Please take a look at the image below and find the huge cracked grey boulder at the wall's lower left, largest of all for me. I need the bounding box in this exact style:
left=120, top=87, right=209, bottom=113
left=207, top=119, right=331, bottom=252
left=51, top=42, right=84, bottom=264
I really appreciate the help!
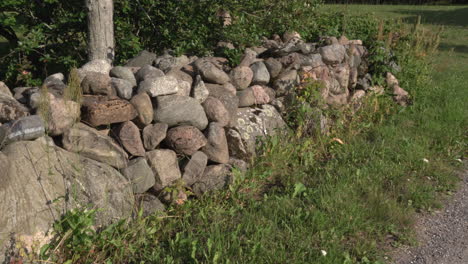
left=0, top=138, right=134, bottom=262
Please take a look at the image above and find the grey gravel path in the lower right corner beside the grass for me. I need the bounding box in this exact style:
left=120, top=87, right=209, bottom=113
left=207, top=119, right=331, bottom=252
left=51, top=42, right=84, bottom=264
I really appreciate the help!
left=392, top=166, right=468, bottom=264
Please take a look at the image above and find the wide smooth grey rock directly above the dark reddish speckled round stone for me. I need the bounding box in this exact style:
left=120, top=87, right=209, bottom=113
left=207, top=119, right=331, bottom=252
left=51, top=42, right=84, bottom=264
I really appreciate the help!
left=154, top=95, right=208, bottom=130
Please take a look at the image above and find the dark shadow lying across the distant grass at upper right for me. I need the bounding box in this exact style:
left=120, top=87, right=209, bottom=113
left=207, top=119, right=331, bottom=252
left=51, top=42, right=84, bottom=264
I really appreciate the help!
left=394, top=7, right=468, bottom=27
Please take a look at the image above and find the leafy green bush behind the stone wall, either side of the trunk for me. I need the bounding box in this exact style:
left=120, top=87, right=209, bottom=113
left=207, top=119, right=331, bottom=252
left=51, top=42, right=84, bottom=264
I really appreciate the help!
left=0, top=0, right=321, bottom=85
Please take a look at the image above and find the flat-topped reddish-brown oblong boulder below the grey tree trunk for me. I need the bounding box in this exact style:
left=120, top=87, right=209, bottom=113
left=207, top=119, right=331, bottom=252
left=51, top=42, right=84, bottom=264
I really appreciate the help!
left=82, top=96, right=138, bottom=127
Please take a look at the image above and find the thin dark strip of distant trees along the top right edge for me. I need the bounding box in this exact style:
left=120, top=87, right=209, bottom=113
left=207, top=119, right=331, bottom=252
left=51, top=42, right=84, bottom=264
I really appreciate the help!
left=325, top=0, right=468, bottom=5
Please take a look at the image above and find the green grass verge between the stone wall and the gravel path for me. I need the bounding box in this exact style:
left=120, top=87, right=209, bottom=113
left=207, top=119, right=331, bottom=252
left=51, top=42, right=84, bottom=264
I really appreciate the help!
left=35, top=6, right=468, bottom=264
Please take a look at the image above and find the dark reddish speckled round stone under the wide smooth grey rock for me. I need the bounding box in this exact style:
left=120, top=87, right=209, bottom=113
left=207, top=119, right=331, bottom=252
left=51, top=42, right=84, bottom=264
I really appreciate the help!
left=165, top=126, right=207, bottom=155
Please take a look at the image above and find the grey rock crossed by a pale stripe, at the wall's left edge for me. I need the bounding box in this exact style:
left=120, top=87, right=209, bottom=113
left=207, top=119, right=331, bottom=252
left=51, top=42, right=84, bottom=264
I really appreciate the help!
left=0, top=115, right=45, bottom=145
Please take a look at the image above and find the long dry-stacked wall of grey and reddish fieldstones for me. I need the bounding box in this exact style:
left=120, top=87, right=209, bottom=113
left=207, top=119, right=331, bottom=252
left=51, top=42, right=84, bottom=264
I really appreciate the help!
left=0, top=33, right=407, bottom=260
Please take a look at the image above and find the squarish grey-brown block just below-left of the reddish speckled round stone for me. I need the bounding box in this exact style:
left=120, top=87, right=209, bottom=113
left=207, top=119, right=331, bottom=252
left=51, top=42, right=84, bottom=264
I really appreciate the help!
left=146, top=149, right=182, bottom=191
